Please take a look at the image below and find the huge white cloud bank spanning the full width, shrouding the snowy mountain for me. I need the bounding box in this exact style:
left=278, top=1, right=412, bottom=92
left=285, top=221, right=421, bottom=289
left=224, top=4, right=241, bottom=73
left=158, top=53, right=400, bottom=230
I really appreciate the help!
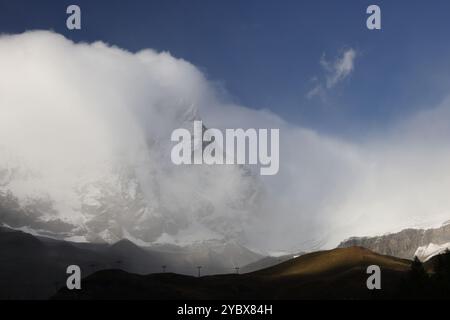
left=0, top=32, right=450, bottom=251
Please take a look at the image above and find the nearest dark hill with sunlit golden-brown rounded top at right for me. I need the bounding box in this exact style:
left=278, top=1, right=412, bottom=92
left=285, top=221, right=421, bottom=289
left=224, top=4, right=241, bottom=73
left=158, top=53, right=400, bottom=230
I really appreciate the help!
left=54, top=247, right=411, bottom=300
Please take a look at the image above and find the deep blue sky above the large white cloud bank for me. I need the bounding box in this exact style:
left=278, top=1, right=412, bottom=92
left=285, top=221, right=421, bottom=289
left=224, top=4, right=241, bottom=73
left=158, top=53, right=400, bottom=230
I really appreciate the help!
left=0, top=0, right=450, bottom=137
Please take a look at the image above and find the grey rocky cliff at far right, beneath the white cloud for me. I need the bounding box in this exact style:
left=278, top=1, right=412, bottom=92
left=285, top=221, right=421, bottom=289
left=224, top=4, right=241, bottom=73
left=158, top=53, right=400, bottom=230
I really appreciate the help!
left=338, top=223, right=450, bottom=259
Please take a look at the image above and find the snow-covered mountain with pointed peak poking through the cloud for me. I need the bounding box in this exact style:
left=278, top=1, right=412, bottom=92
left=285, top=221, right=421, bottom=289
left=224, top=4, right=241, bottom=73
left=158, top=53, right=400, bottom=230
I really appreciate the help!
left=0, top=106, right=263, bottom=245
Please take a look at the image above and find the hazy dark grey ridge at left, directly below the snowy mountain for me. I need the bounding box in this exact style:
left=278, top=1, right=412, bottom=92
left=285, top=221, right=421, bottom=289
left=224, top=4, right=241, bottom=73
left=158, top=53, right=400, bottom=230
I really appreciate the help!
left=0, top=227, right=262, bottom=300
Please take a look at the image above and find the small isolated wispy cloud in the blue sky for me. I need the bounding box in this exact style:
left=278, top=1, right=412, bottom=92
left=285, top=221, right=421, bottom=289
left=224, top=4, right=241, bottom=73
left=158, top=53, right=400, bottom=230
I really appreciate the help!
left=306, top=48, right=357, bottom=99
